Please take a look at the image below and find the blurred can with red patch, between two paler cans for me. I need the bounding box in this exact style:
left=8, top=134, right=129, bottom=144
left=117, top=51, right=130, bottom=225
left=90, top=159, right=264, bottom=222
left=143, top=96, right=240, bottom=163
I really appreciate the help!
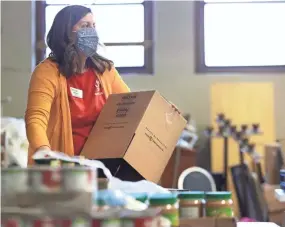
left=29, top=166, right=62, bottom=193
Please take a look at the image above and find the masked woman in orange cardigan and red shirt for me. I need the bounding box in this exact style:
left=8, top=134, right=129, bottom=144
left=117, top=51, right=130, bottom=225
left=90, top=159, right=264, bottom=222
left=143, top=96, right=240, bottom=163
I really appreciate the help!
left=25, top=5, right=130, bottom=165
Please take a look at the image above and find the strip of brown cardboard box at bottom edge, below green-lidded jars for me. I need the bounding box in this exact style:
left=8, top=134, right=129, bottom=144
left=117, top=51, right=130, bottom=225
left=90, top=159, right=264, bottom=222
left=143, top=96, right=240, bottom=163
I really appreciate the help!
left=180, top=218, right=237, bottom=227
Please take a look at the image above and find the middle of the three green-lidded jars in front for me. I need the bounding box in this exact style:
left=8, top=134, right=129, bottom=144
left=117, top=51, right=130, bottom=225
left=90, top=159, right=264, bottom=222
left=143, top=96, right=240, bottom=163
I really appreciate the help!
left=178, top=191, right=205, bottom=218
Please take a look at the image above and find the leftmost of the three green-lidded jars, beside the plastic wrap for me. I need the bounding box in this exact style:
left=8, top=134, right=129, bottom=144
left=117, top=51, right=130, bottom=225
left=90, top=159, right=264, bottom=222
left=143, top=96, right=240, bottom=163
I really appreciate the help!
left=149, top=193, right=179, bottom=226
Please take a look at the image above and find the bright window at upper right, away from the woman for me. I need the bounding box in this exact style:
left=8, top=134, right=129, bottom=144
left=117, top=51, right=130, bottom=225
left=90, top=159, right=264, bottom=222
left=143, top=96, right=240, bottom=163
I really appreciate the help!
left=195, top=0, right=285, bottom=72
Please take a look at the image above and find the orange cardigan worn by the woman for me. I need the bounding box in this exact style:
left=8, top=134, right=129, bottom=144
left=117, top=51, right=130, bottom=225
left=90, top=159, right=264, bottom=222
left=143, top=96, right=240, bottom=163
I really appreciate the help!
left=25, top=59, right=130, bottom=165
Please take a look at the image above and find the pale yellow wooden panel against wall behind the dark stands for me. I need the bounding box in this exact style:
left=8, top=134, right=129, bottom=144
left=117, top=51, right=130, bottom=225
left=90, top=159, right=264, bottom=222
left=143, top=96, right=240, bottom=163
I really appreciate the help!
left=211, top=83, right=276, bottom=215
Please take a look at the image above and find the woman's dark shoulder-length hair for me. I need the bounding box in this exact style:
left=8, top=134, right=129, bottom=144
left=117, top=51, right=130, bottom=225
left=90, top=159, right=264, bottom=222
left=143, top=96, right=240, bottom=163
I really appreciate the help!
left=47, top=5, right=113, bottom=78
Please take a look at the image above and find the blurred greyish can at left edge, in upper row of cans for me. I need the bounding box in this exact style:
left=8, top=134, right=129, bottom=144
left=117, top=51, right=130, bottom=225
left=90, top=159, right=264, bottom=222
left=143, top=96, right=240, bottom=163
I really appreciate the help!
left=1, top=167, right=29, bottom=195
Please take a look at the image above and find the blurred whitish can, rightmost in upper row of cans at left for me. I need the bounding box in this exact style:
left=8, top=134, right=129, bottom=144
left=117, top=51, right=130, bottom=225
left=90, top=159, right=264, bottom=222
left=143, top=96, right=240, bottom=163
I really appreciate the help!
left=62, top=166, right=97, bottom=192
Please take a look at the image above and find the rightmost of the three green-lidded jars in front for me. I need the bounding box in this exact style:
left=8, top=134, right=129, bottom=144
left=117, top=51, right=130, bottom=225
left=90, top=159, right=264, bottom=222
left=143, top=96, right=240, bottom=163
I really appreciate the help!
left=205, top=191, right=234, bottom=217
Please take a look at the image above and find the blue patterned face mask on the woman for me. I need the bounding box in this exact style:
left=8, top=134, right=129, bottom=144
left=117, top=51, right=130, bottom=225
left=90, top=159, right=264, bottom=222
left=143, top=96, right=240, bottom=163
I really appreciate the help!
left=76, top=28, right=99, bottom=57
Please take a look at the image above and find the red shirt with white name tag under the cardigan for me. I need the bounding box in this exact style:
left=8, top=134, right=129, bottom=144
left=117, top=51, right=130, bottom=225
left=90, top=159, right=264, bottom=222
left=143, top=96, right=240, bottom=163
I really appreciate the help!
left=67, top=69, right=106, bottom=155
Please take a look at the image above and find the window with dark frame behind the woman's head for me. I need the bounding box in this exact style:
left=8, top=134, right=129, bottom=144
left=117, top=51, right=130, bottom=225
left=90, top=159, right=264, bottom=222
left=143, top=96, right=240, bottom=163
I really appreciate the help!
left=37, top=0, right=153, bottom=74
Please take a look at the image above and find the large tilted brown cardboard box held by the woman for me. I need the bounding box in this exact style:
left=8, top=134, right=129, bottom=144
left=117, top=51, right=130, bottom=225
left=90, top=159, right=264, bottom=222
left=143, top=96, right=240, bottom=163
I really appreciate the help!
left=81, top=91, right=186, bottom=183
